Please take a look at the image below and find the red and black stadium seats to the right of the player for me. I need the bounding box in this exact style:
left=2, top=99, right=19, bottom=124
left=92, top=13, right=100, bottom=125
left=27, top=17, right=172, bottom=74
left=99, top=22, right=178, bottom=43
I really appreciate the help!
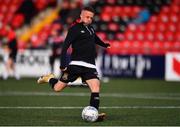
left=92, top=0, right=180, bottom=55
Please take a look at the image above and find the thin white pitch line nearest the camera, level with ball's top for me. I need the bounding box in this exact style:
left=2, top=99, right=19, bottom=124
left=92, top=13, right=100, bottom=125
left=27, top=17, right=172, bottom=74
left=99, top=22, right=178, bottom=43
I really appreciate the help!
left=0, top=106, right=180, bottom=110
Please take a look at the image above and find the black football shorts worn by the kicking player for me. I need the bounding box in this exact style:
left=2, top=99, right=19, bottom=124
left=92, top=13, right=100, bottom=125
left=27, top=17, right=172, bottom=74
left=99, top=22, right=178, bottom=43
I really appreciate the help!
left=60, top=65, right=99, bottom=83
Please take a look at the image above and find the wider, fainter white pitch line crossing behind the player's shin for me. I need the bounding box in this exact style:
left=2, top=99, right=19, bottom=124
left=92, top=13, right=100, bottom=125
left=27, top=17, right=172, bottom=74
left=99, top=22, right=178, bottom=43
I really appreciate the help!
left=0, top=91, right=180, bottom=100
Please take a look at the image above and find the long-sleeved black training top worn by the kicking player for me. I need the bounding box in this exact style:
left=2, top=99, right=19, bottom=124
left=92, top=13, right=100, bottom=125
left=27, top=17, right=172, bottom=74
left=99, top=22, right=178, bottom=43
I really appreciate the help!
left=60, top=23, right=109, bottom=68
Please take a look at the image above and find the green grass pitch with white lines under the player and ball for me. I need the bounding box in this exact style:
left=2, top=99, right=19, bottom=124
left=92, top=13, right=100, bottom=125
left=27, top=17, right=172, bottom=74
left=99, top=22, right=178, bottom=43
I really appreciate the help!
left=0, top=78, right=180, bottom=126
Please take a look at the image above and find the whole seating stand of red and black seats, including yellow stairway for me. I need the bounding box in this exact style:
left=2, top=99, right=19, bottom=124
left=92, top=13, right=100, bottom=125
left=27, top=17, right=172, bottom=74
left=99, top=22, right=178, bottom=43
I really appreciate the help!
left=0, top=0, right=180, bottom=55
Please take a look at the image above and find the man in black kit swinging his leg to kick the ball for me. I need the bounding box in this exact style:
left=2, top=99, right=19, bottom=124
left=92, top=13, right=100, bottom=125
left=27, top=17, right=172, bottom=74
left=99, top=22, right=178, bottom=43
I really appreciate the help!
left=37, top=7, right=110, bottom=121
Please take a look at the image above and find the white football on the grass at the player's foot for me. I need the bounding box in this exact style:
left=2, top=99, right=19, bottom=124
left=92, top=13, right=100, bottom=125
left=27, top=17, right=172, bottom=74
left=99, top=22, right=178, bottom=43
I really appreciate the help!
left=81, top=106, right=98, bottom=122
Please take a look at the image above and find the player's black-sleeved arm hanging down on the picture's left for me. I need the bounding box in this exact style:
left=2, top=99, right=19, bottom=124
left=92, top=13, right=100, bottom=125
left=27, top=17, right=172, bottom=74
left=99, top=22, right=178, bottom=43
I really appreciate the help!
left=60, top=27, right=77, bottom=71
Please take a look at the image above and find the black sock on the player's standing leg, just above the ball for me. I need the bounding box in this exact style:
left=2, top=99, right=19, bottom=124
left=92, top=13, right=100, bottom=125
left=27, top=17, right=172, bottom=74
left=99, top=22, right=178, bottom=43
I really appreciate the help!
left=90, top=93, right=100, bottom=110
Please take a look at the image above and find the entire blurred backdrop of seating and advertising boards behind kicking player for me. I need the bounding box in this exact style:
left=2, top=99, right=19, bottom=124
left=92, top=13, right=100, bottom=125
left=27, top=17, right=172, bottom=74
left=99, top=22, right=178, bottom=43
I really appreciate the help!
left=0, top=0, right=180, bottom=81
